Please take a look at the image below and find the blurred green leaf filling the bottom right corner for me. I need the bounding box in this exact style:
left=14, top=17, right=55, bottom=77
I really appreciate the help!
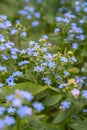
left=71, top=121, right=87, bottom=130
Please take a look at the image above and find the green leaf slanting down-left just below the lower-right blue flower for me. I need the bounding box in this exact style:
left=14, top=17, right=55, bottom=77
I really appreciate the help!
left=53, top=110, right=70, bottom=124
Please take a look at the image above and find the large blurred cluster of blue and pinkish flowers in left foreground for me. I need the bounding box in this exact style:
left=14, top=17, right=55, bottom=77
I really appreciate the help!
left=0, top=89, right=44, bottom=130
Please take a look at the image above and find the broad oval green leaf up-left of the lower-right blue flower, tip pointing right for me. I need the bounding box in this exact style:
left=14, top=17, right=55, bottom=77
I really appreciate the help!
left=44, top=94, right=63, bottom=106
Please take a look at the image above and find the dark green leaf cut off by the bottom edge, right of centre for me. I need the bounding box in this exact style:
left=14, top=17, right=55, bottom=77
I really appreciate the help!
left=42, top=122, right=64, bottom=130
